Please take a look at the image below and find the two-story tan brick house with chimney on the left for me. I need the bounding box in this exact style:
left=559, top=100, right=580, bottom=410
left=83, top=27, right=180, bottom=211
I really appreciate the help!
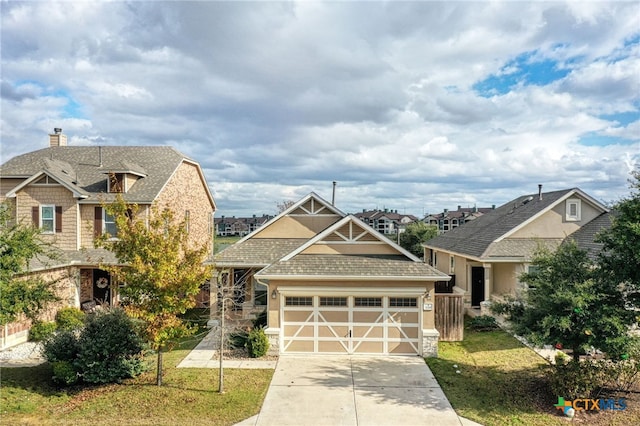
left=0, top=129, right=215, bottom=346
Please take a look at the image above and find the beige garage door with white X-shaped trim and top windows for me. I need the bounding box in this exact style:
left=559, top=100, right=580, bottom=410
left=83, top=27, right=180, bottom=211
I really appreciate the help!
left=282, top=295, right=421, bottom=355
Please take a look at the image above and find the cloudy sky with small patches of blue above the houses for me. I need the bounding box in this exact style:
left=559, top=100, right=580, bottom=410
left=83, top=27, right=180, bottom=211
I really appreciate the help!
left=0, top=0, right=640, bottom=217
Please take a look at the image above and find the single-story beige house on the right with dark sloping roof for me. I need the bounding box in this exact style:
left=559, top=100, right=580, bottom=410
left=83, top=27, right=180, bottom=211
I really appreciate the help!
left=424, top=186, right=608, bottom=308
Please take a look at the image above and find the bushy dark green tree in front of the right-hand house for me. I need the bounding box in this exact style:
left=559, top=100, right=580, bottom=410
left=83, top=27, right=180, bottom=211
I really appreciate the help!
left=492, top=240, right=633, bottom=360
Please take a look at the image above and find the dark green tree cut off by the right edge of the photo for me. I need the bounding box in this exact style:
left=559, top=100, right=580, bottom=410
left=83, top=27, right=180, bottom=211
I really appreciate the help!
left=598, top=170, right=640, bottom=308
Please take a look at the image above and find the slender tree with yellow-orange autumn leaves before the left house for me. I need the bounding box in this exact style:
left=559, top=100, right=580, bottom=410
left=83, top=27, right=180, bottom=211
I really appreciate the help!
left=96, top=197, right=211, bottom=386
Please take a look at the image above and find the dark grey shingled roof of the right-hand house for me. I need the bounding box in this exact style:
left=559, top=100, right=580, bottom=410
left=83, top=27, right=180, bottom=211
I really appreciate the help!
left=424, top=188, right=598, bottom=258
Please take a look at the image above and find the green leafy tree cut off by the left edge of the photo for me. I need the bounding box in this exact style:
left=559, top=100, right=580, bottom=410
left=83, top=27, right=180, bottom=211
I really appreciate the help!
left=0, top=203, right=59, bottom=325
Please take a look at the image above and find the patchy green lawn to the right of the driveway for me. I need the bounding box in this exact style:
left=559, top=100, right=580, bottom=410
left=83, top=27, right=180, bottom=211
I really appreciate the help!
left=427, top=328, right=640, bottom=426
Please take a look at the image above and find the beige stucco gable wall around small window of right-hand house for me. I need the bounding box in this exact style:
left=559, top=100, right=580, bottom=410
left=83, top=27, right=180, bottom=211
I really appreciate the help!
left=509, top=197, right=602, bottom=238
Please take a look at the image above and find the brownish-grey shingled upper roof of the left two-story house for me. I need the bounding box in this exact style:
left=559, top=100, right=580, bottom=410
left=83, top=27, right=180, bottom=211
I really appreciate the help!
left=0, top=146, right=197, bottom=203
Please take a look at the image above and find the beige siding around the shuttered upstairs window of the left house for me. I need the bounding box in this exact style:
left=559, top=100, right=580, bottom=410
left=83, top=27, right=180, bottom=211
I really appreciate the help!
left=16, top=185, right=78, bottom=250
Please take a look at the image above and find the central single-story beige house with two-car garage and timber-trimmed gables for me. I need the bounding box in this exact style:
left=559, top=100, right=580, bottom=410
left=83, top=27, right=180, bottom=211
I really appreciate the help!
left=215, top=193, right=449, bottom=356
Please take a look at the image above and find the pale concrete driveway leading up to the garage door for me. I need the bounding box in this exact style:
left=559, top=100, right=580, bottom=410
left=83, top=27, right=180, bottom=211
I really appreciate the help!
left=249, top=356, right=466, bottom=426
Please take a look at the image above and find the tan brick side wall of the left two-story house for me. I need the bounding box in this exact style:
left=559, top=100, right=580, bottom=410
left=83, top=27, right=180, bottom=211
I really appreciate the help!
left=156, top=162, right=213, bottom=250
